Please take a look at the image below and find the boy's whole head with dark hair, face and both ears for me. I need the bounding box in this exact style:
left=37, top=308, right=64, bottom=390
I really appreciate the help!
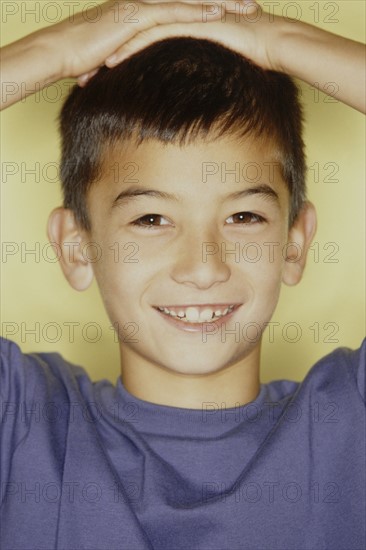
left=49, top=38, right=315, bottom=383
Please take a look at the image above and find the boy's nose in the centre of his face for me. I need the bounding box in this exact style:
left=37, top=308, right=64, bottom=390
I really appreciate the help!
left=171, top=230, right=231, bottom=290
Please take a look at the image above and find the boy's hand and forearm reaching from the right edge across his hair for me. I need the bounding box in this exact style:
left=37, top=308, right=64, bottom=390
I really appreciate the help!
left=101, top=0, right=366, bottom=113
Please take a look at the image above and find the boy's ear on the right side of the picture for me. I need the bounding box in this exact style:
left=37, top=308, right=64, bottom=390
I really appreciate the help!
left=282, top=201, right=316, bottom=286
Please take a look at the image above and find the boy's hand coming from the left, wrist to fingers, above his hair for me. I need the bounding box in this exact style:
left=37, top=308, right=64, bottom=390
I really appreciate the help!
left=40, top=0, right=230, bottom=85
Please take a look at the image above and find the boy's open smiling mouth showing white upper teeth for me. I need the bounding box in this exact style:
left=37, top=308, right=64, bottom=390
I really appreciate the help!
left=154, top=304, right=241, bottom=325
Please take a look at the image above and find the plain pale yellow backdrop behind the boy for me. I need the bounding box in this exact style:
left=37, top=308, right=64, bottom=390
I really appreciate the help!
left=1, top=0, right=365, bottom=382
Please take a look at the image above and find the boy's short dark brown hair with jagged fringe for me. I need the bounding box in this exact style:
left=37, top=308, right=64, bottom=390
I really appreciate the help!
left=60, top=37, right=306, bottom=230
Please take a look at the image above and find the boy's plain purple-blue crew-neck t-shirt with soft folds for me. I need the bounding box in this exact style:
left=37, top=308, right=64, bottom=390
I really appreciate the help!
left=0, top=339, right=366, bottom=550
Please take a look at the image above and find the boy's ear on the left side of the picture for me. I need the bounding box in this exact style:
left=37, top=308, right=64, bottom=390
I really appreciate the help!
left=47, top=207, right=93, bottom=290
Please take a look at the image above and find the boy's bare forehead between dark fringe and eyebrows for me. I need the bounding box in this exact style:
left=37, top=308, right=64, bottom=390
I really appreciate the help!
left=90, top=136, right=288, bottom=206
